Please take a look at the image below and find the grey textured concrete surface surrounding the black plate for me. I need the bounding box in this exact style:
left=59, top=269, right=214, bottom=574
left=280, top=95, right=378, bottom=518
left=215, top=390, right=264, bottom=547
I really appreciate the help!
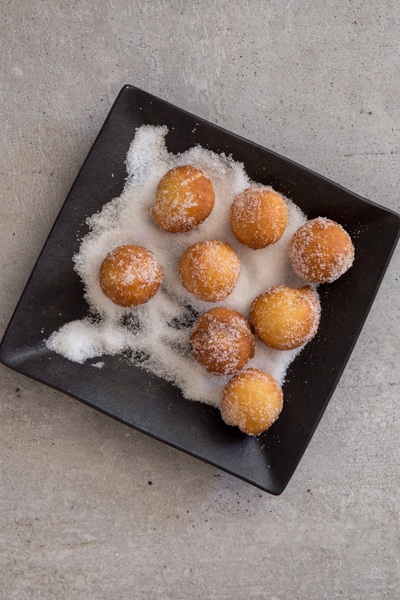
left=0, top=0, right=400, bottom=600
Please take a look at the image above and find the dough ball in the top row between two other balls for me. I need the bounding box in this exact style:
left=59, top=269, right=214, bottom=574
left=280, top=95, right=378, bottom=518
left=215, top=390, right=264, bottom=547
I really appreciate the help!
left=230, top=186, right=289, bottom=250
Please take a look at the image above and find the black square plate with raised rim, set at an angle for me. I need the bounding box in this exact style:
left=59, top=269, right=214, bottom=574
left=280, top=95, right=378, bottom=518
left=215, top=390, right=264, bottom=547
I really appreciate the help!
left=0, top=86, right=400, bottom=494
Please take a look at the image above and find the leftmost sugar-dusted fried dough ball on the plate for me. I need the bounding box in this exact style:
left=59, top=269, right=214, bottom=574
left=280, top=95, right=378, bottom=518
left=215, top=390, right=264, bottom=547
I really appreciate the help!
left=99, top=245, right=164, bottom=307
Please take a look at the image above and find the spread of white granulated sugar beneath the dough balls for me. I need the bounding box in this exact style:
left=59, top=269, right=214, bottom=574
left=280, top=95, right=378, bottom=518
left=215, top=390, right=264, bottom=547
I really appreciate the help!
left=46, top=126, right=306, bottom=406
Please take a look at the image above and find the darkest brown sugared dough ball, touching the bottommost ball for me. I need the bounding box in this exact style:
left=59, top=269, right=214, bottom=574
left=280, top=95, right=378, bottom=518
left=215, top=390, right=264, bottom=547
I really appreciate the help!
left=190, top=306, right=255, bottom=375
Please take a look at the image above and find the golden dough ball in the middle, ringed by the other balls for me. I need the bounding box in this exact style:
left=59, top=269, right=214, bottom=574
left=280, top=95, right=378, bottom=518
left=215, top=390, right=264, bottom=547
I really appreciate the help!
left=179, top=240, right=240, bottom=302
